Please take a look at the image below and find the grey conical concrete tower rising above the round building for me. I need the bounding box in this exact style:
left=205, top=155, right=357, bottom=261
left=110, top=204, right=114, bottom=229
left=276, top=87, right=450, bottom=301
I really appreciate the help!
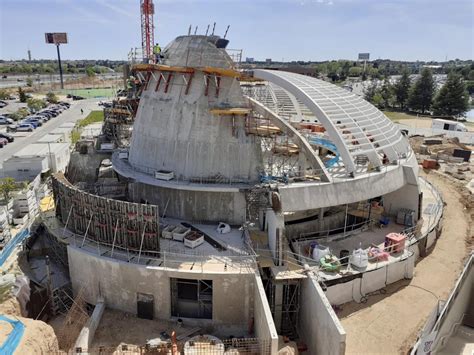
left=129, top=36, right=261, bottom=181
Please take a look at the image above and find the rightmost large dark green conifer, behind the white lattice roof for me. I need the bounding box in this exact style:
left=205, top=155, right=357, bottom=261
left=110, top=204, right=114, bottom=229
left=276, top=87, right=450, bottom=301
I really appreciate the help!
left=433, top=72, right=469, bottom=117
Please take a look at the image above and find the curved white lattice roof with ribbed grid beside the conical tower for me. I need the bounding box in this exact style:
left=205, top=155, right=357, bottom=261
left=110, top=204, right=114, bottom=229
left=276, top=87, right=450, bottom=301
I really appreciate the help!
left=254, top=69, right=410, bottom=172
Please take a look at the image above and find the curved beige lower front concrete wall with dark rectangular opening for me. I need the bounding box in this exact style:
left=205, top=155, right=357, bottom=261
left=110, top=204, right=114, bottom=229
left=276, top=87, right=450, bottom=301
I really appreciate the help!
left=68, top=245, right=255, bottom=336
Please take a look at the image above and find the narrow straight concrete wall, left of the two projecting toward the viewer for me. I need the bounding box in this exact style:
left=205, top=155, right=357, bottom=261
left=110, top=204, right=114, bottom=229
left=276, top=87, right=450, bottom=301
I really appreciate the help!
left=253, top=275, right=278, bottom=354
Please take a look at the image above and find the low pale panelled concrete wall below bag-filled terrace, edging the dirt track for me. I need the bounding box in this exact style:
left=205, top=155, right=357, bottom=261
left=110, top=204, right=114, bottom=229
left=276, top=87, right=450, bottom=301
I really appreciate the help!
left=326, top=254, right=416, bottom=305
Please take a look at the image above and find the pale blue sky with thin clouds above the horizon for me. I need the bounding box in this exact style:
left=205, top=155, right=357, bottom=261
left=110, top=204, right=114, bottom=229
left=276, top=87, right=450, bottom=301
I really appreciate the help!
left=0, top=0, right=474, bottom=61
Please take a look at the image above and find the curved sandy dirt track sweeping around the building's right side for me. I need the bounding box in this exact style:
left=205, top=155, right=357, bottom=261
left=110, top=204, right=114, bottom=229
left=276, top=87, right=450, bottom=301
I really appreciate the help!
left=338, top=174, right=473, bottom=354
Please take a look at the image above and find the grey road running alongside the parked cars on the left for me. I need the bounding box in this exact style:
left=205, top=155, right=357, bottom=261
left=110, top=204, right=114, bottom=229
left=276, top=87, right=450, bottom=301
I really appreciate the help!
left=0, top=99, right=101, bottom=175
